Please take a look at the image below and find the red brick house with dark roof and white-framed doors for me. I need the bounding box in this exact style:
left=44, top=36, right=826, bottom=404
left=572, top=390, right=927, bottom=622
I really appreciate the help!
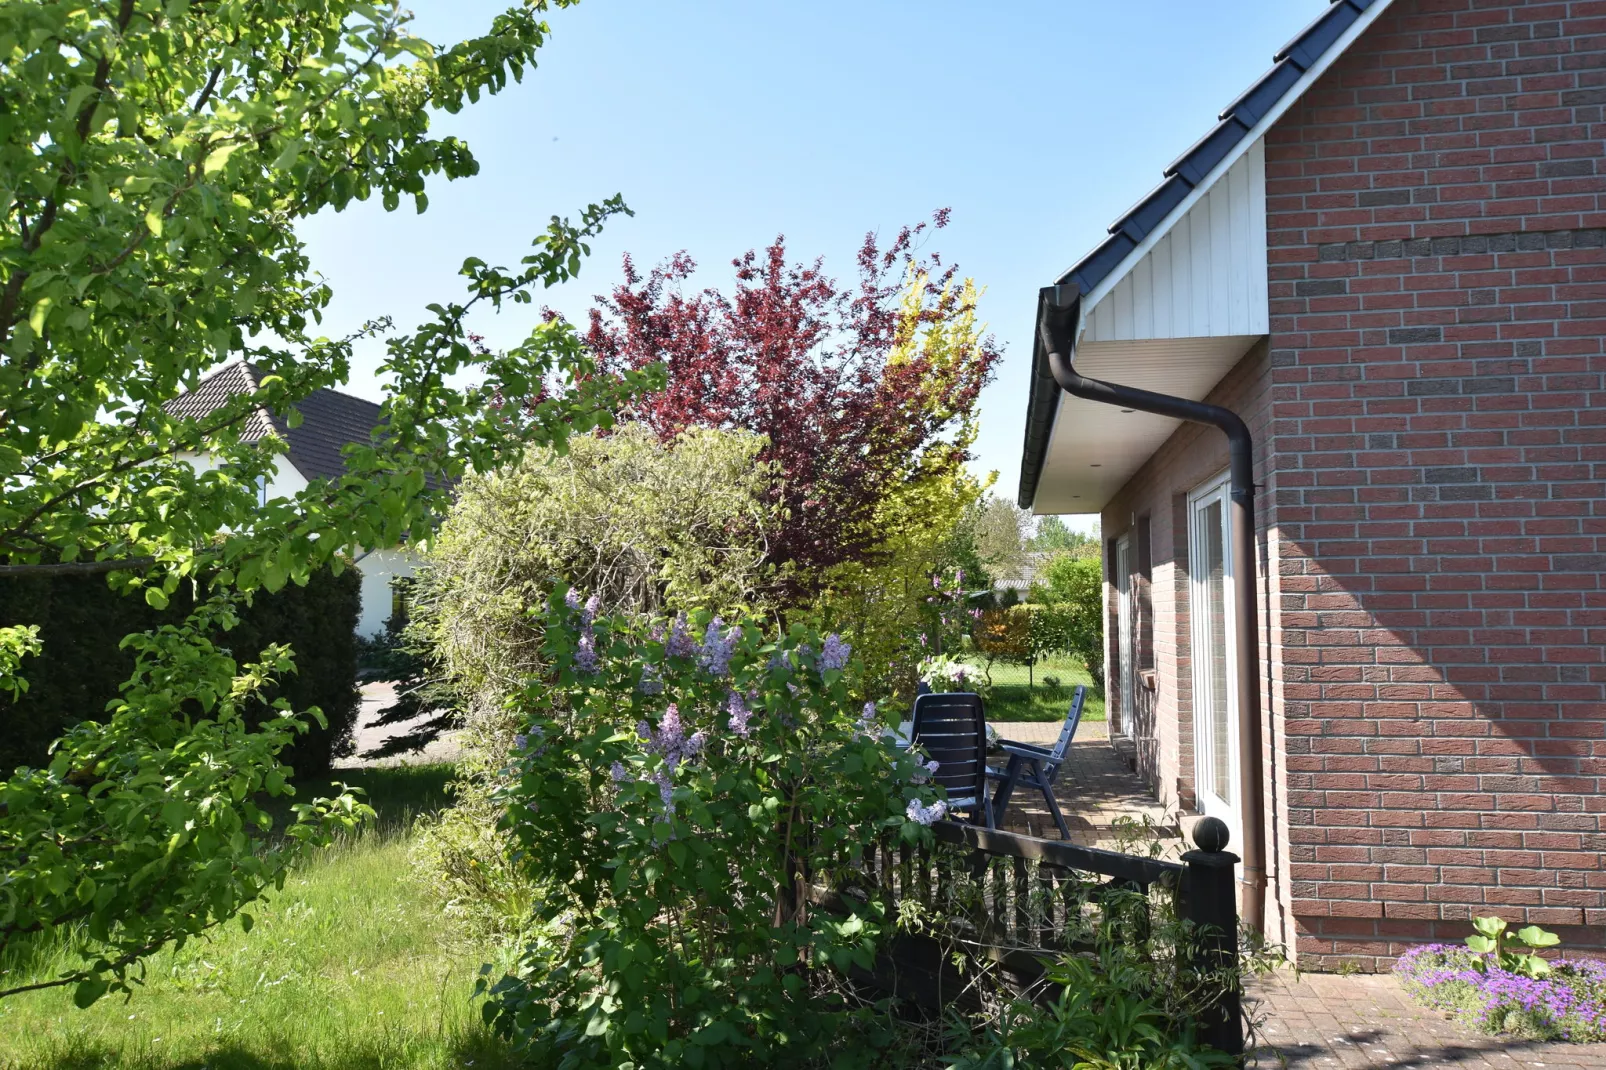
left=1020, top=0, right=1606, bottom=969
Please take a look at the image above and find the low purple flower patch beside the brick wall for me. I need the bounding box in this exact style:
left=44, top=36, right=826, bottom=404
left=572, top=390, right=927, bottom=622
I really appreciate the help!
left=1394, top=943, right=1606, bottom=1041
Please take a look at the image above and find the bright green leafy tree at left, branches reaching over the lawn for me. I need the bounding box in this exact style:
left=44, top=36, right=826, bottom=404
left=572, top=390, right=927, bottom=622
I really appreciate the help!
left=0, top=0, right=655, bottom=1006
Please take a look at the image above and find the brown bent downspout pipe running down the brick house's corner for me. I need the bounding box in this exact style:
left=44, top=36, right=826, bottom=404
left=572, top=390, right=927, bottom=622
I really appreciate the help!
left=1037, top=286, right=1266, bottom=933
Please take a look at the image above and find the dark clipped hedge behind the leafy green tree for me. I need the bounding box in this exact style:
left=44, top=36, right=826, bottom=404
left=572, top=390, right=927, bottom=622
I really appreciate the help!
left=0, top=569, right=361, bottom=776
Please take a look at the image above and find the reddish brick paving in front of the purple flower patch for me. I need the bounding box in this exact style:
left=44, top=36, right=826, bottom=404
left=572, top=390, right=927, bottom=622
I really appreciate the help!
left=1249, top=974, right=1606, bottom=1070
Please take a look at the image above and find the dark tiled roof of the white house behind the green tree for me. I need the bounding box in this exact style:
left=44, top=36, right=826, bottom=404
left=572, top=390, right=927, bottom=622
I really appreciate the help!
left=165, top=360, right=379, bottom=479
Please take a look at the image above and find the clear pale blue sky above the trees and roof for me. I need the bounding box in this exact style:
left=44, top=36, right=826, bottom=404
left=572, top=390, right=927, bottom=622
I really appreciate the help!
left=302, top=0, right=1327, bottom=530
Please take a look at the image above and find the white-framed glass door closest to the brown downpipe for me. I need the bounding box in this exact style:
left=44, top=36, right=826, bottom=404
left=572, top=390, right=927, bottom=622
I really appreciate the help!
left=1188, top=476, right=1238, bottom=839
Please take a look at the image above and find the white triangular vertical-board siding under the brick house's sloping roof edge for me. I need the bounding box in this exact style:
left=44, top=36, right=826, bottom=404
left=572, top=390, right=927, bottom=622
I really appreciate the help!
left=1082, top=140, right=1270, bottom=344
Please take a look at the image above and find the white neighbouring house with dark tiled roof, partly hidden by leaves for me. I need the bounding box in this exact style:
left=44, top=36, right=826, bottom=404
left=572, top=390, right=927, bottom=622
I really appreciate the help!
left=167, top=360, right=414, bottom=635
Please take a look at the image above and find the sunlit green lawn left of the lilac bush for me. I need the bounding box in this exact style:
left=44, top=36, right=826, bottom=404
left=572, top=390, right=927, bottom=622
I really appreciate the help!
left=0, top=766, right=517, bottom=1070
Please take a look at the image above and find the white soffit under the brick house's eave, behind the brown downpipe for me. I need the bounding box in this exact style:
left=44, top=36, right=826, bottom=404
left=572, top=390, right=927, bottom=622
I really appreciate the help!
left=1033, top=333, right=1264, bottom=516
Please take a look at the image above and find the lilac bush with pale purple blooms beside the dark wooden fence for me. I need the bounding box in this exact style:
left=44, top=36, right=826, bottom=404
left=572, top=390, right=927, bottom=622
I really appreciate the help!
left=483, top=588, right=943, bottom=1068
